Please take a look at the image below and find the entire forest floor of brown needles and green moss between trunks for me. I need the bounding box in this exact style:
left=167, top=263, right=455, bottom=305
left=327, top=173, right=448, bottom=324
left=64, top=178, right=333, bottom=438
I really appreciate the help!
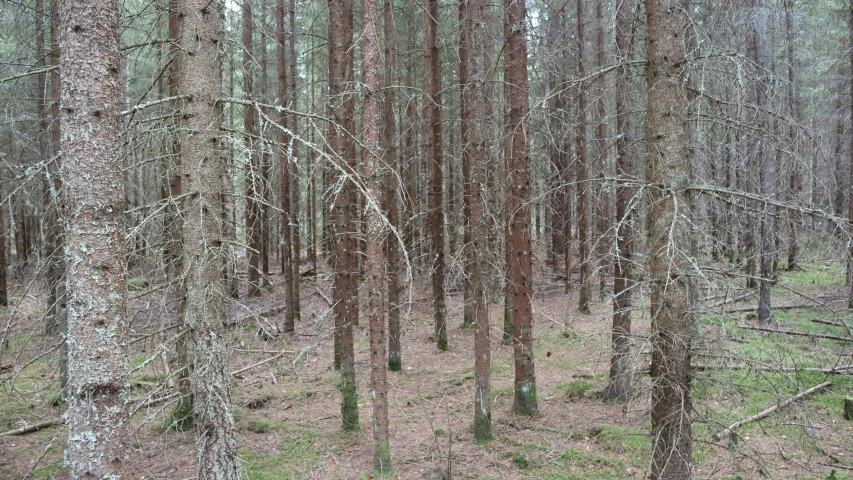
left=0, top=253, right=853, bottom=480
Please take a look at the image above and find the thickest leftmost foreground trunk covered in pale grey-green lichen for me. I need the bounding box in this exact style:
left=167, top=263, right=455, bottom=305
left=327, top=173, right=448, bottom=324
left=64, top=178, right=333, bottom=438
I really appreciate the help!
left=59, top=0, right=130, bottom=478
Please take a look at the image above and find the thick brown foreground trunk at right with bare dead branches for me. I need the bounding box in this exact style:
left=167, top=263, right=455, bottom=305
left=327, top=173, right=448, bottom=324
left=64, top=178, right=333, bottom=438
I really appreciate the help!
left=646, top=0, right=692, bottom=479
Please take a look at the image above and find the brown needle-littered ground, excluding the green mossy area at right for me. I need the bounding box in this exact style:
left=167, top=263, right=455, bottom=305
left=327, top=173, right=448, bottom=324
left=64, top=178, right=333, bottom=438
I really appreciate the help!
left=0, top=260, right=853, bottom=480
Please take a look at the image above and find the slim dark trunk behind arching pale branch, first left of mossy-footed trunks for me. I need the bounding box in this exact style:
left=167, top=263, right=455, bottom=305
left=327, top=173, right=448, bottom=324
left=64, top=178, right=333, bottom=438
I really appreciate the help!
left=276, top=0, right=299, bottom=333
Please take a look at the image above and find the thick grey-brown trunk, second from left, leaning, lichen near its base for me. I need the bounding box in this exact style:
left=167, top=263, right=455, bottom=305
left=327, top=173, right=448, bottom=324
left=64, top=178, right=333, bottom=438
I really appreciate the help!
left=178, top=0, right=240, bottom=480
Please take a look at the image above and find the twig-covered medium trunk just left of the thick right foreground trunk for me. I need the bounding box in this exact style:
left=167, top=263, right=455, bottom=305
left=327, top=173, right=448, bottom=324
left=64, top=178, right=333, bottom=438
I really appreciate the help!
left=605, top=1, right=636, bottom=402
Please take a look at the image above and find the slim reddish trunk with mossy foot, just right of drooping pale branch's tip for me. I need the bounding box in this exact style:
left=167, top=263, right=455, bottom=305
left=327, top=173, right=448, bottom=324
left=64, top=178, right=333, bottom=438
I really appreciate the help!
left=424, top=0, right=447, bottom=351
